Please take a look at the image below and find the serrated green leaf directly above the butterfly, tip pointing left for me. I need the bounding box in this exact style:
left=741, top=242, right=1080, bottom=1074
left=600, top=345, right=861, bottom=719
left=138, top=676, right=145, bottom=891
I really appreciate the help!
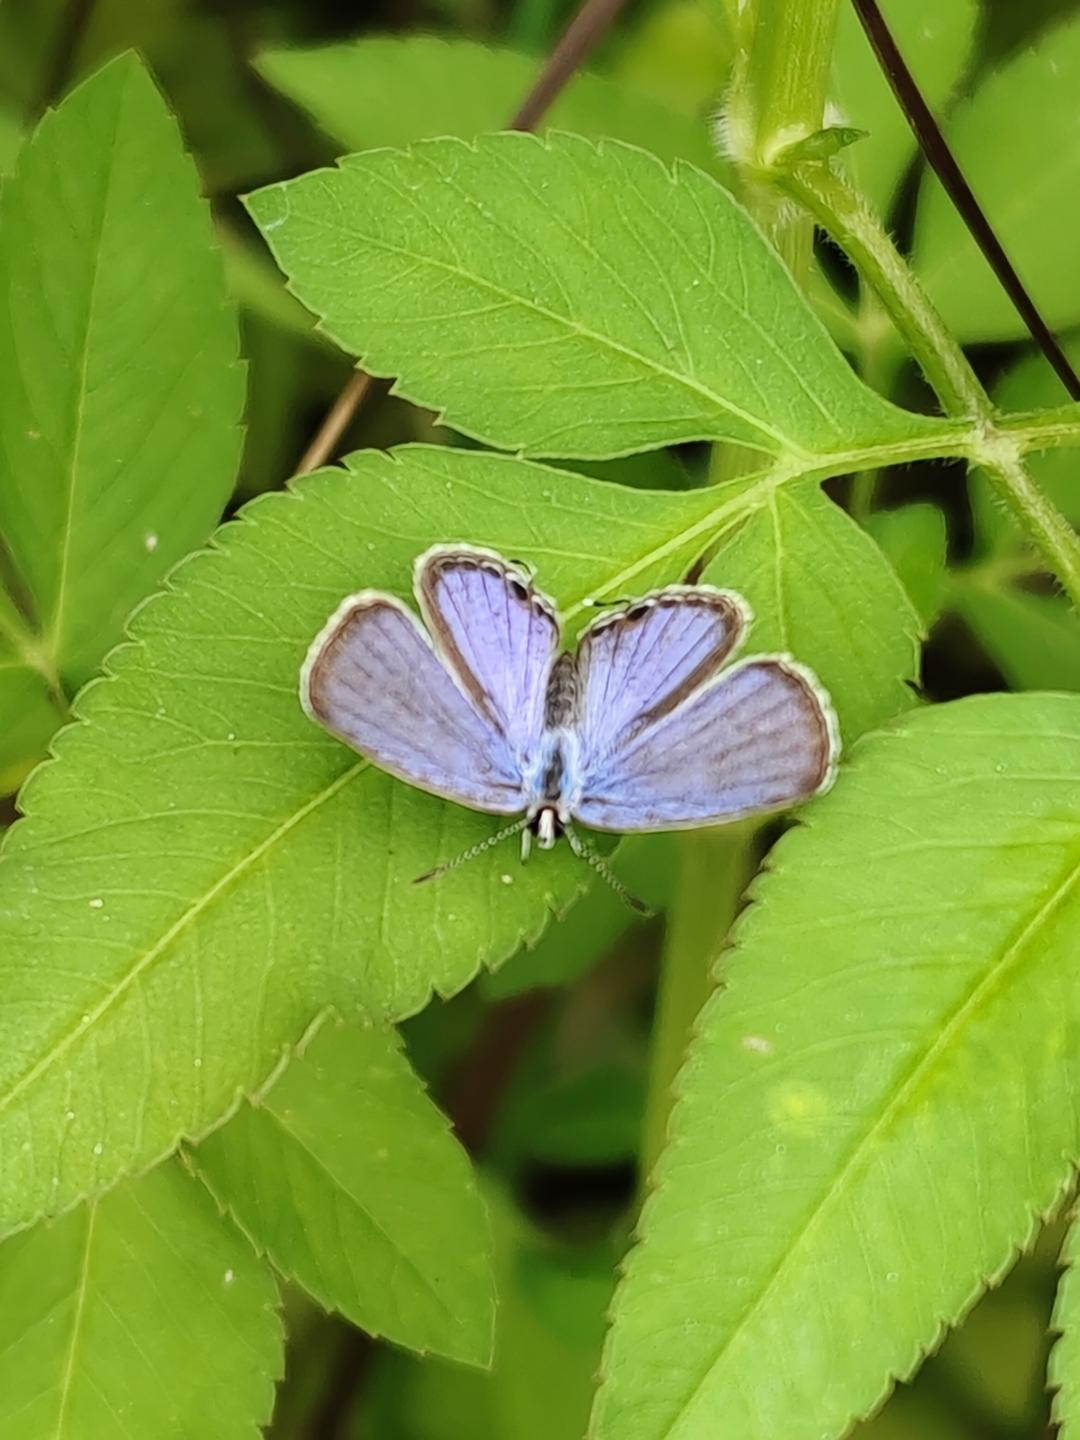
left=248, top=135, right=940, bottom=459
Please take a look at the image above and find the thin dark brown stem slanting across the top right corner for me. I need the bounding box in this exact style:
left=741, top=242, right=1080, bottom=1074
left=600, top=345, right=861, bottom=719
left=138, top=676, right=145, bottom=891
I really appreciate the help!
left=851, top=0, right=1080, bottom=400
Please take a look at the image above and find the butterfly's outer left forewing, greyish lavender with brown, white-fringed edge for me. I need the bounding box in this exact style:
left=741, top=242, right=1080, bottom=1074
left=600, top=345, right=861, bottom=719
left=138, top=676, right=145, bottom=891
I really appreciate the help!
left=300, top=590, right=524, bottom=815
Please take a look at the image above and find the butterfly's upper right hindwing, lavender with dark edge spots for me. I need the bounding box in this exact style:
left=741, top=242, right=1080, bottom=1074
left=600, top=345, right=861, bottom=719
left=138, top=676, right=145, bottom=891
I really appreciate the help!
left=577, top=585, right=749, bottom=768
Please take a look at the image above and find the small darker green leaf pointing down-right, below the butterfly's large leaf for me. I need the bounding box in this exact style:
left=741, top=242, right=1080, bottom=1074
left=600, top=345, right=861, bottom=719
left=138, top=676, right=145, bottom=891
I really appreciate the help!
left=192, top=1025, right=495, bottom=1365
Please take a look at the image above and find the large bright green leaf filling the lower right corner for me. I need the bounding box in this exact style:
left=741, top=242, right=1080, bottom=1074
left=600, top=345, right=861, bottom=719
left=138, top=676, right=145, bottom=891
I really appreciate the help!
left=592, top=696, right=1080, bottom=1440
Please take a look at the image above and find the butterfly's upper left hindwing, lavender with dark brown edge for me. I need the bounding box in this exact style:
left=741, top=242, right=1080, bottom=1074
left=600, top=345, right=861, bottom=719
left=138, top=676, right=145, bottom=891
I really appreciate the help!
left=416, top=546, right=559, bottom=759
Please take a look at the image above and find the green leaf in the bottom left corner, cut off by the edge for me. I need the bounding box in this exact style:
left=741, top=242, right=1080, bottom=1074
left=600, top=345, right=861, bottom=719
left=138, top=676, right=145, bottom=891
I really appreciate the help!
left=0, top=1165, right=282, bottom=1440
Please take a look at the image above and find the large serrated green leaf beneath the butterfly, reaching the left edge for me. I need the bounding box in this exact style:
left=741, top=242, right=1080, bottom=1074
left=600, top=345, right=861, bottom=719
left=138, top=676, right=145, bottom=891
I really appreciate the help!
left=0, top=446, right=913, bottom=1227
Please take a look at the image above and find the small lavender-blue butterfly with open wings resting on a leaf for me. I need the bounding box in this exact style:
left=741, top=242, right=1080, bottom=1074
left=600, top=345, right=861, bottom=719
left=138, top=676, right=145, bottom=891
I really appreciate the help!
left=300, top=546, right=840, bottom=878
